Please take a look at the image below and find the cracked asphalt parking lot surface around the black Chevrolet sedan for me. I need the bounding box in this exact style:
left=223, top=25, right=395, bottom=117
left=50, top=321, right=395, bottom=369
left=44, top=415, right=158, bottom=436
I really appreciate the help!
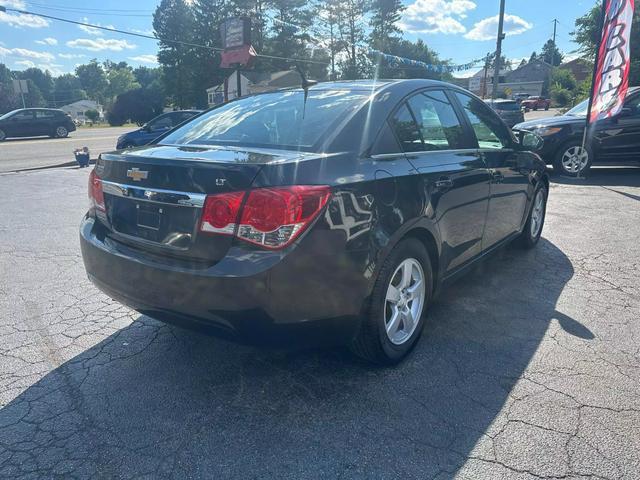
left=0, top=164, right=640, bottom=480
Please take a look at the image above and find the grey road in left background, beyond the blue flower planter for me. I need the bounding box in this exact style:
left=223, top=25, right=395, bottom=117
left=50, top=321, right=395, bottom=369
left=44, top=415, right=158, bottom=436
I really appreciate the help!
left=0, top=127, right=132, bottom=173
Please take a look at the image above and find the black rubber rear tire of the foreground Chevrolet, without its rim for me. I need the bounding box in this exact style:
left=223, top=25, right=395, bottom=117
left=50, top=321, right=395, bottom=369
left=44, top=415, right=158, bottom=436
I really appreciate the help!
left=350, top=238, right=433, bottom=365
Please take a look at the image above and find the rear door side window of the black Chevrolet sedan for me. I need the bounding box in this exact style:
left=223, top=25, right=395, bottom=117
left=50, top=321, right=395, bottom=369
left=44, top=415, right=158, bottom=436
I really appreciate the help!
left=408, top=90, right=464, bottom=151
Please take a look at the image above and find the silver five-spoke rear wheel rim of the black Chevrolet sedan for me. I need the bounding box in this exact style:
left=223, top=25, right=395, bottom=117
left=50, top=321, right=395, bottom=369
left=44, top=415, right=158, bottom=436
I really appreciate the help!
left=384, top=258, right=425, bottom=345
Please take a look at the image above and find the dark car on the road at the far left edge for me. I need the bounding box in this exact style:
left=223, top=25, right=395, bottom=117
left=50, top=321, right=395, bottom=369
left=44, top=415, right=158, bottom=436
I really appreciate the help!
left=0, top=108, right=76, bottom=142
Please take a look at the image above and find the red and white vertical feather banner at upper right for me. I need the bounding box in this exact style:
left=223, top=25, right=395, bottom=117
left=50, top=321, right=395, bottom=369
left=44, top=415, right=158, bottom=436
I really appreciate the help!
left=588, top=0, right=634, bottom=123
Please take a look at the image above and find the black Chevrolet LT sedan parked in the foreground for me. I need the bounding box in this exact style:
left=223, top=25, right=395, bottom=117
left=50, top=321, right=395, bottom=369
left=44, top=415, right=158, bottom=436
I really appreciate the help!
left=80, top=80, right=549, bottom=363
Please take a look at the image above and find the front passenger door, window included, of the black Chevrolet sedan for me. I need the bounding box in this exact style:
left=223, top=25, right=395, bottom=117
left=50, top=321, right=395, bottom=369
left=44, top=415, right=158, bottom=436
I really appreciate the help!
left=455, top=92, right=532, bottom=249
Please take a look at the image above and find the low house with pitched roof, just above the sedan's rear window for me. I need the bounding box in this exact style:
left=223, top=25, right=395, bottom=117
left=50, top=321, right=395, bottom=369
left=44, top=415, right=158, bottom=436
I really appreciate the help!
left=207, top=70, right=302, bottom=107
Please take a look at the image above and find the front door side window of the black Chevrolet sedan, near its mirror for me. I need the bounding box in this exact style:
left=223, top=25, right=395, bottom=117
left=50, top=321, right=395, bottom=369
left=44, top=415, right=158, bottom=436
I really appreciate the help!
left=456, top=92, right=511, bottom=150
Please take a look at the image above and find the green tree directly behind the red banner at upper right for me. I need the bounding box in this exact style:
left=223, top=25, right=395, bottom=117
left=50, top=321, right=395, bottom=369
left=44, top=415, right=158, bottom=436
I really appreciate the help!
left=571, top=2, right=640, bottom=85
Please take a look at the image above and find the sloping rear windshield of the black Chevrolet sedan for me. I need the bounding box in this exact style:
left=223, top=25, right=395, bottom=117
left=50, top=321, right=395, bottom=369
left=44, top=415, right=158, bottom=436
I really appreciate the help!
left=158, top=90, right=370, bottom=149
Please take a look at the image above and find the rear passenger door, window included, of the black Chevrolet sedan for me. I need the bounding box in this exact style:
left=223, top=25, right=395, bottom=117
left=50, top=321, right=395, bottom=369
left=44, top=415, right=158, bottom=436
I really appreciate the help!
left=391, top=89, right=489, bottom=273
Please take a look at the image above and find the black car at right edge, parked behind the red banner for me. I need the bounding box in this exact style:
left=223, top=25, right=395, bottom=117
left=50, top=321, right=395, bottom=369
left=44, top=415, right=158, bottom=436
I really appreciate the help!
left=513, top=87, right=640, bottom=176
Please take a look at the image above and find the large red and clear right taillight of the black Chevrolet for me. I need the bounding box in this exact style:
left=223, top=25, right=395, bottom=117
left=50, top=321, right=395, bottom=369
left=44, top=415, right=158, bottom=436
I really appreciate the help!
left=200, top=185, right=331, bottom=249
